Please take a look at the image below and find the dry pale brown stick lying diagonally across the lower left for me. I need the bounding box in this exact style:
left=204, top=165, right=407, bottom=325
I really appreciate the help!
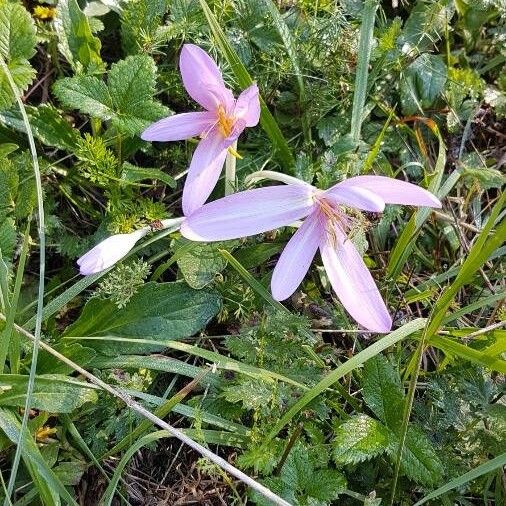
left=0, top=313, right=291, bottom=506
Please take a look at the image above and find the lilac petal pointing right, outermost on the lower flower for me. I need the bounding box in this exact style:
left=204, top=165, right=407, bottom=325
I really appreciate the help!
left=336, top=176, right=441, bottom=208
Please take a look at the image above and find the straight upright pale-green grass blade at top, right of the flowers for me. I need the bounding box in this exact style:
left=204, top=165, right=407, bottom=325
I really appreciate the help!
left=351, top=0, right=378, bottom=144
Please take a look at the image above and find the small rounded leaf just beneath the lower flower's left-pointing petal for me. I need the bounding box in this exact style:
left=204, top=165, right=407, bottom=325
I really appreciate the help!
left=177, top=241, right=227, bottom=289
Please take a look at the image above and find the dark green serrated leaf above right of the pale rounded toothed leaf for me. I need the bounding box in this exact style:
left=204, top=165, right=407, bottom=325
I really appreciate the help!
left=362, top=355, right=404, bottom=432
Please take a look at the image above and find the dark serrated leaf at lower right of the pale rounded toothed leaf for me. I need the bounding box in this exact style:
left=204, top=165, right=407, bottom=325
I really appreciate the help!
left=387, top=426, right=443, bottom=486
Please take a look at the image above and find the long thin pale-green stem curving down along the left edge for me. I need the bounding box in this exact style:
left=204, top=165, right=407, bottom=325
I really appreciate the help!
left=0, top=56, right=46, bottom=498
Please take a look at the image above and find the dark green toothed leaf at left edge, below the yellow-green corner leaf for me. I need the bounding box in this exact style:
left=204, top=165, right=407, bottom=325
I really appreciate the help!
left=0, top=104, right=79, bottom=152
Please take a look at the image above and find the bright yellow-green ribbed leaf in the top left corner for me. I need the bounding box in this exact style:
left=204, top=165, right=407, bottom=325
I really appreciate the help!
left=0, top=1, right=37, bottom=110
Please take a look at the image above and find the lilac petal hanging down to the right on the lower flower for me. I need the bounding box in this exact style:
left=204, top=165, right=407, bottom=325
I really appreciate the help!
left=320, top=229, right=392, bottom=332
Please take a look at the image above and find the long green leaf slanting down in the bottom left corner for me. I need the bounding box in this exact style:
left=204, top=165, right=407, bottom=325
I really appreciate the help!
left=0, top=408, right=78, bottom=506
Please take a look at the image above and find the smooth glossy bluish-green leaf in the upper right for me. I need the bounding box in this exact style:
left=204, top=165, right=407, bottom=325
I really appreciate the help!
left=401, top=53, right=448, bottom=114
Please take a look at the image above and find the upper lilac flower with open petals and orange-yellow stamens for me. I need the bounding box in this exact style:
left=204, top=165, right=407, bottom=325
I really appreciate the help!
left=141, top=44, right=260, bottom=216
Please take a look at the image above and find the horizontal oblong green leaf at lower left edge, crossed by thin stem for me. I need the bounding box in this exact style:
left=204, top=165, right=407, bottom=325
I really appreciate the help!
left=0, top=374, right=97, bottom=413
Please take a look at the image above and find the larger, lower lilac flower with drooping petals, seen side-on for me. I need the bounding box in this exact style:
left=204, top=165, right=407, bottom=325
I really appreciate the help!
left=181, top=176, right=441, bottom=332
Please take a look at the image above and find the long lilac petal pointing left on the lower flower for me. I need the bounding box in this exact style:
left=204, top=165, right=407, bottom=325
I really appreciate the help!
left=181, top=184, right=314, bottom=241
